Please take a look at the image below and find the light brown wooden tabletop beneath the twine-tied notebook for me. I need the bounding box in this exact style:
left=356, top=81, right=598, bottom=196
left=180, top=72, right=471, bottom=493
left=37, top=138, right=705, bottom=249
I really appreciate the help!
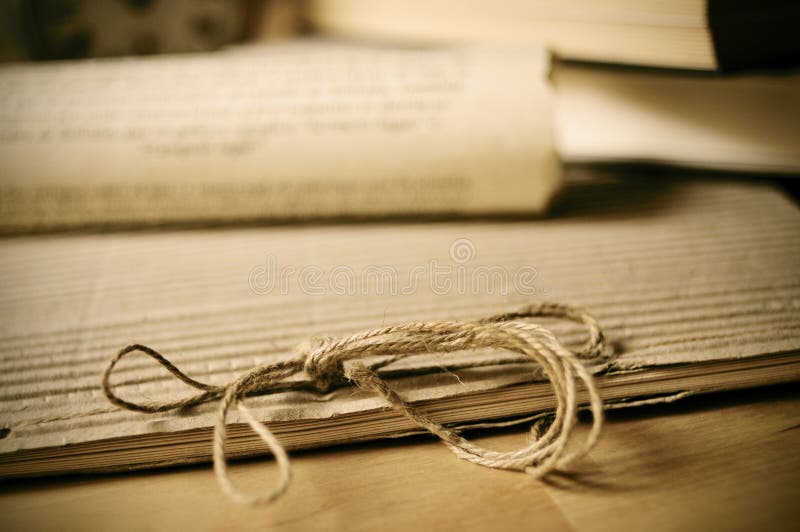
left=0, top=384, right=800, bottom=532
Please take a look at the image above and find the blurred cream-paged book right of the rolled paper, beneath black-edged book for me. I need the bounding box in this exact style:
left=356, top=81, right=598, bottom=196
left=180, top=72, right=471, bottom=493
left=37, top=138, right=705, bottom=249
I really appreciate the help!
left=551, top=62, right=800, bottom=174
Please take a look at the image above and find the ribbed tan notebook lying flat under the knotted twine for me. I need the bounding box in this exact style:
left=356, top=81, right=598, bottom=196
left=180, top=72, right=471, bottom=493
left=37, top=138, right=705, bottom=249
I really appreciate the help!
left=0, top=176, right=800, bottom=477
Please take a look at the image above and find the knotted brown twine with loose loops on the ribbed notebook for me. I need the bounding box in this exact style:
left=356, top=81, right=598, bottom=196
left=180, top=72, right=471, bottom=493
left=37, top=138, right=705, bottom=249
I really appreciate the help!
left=102, top=303, right=604, bottom=504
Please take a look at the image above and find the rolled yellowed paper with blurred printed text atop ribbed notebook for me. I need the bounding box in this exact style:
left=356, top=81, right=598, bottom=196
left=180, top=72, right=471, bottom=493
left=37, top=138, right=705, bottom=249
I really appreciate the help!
left=0, top=41, right=560, bottom=233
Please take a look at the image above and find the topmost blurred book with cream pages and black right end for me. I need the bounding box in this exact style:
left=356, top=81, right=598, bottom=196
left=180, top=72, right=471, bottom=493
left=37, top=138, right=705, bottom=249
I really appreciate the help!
left=306, top=0, right=800, bottom=70
